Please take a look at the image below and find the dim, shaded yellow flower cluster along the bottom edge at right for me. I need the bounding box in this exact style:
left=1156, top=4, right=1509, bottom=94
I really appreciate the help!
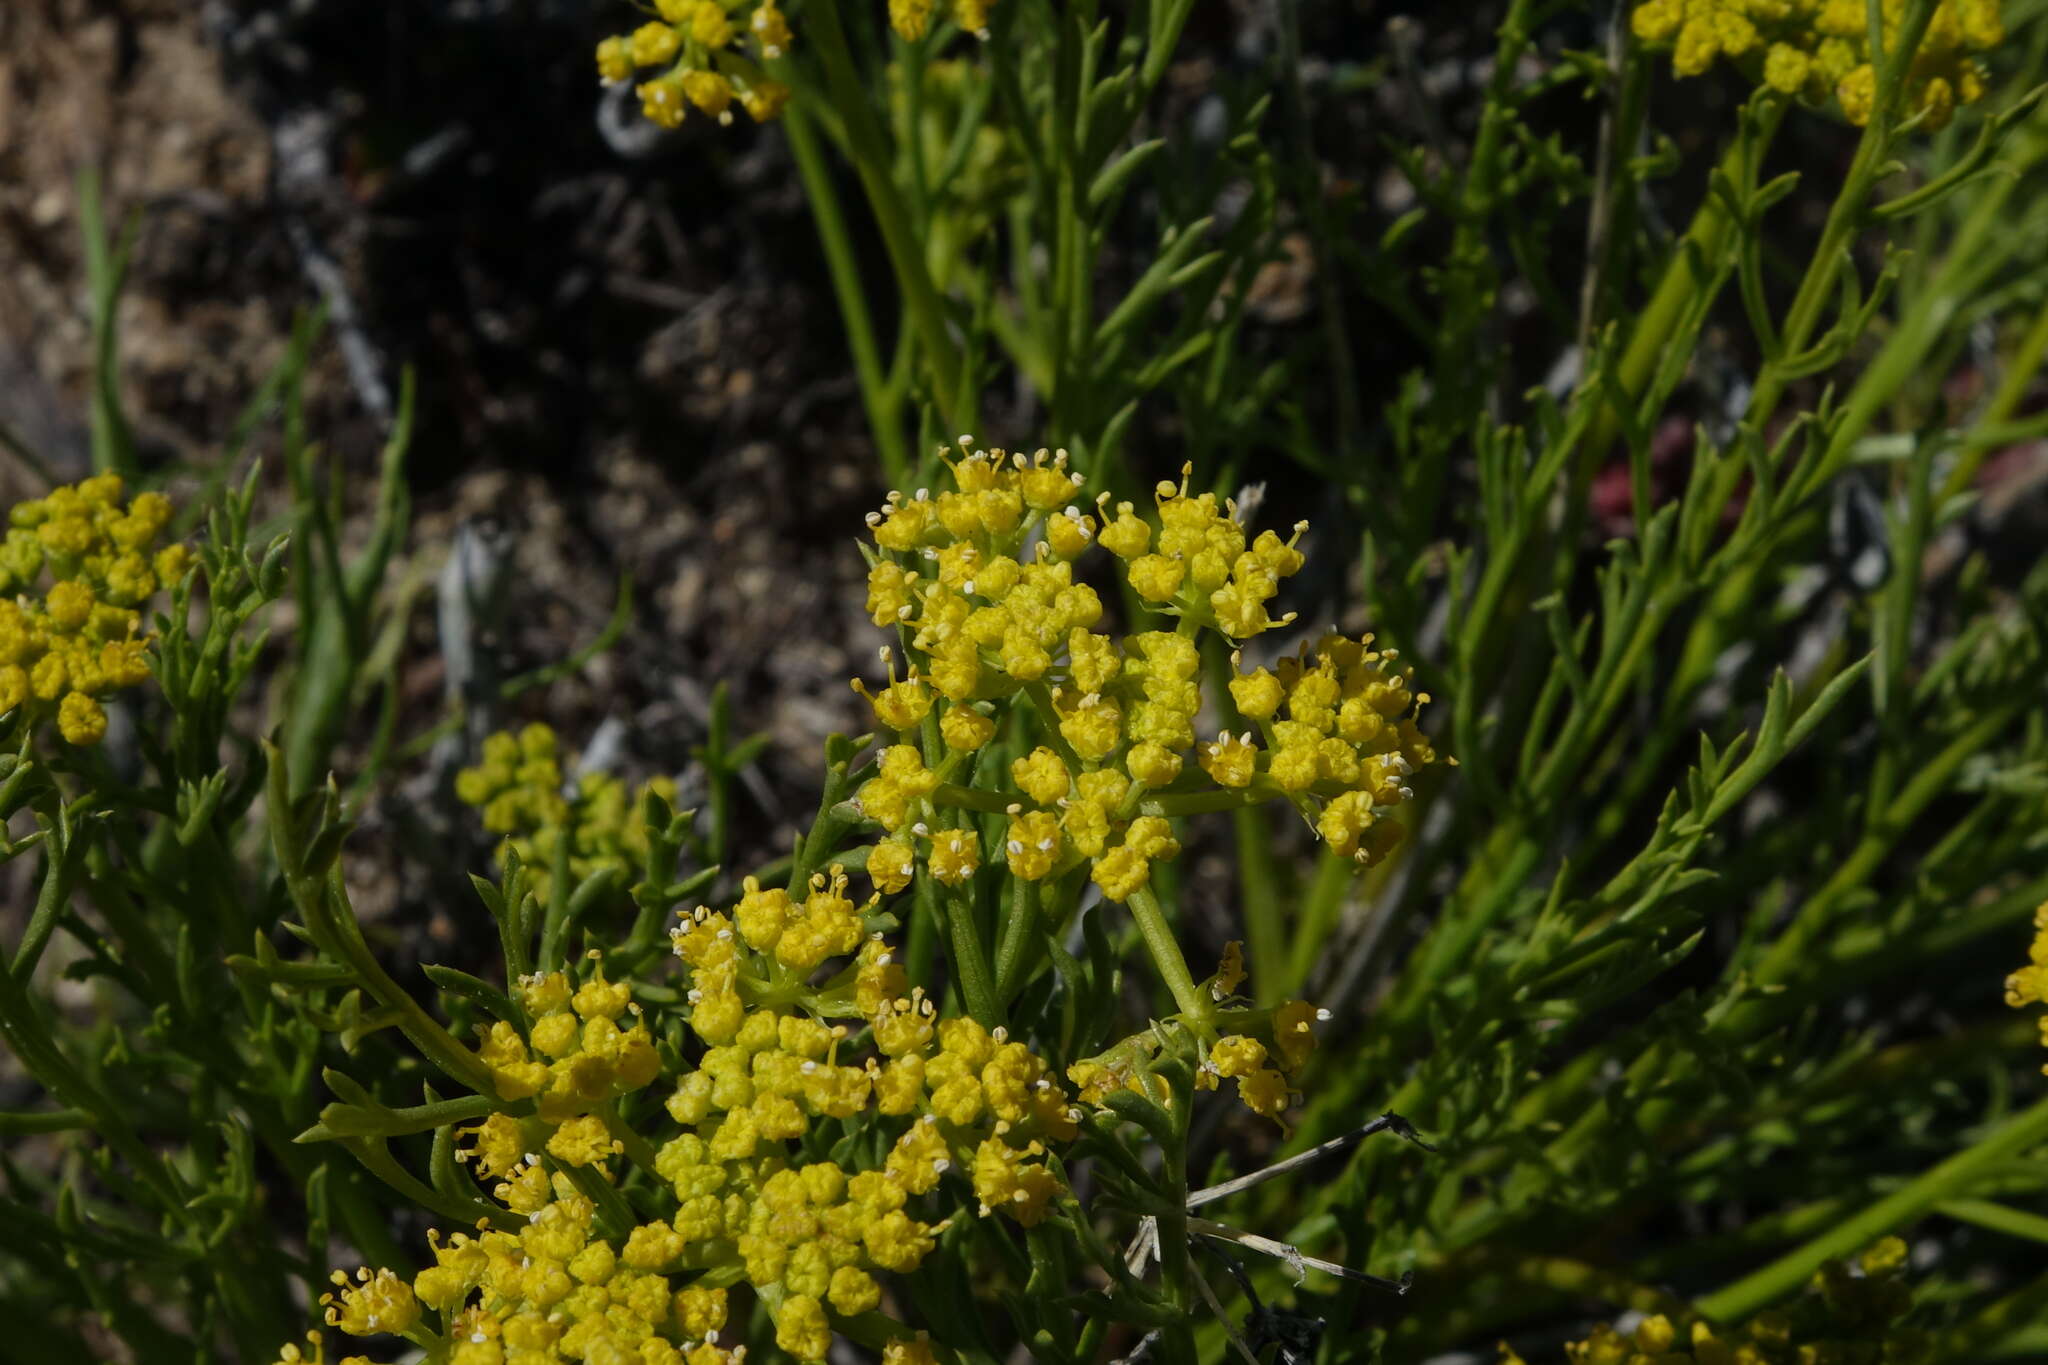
left=1499, top=1236, right=1931, bottom=1365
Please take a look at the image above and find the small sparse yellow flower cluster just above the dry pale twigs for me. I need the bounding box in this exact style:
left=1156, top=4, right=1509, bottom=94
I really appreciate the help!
left=1067, top=943, right=1329, bottom=1126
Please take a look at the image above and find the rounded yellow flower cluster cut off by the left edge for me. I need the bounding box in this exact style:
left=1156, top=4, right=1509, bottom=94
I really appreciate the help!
left=0, top=475, right=190, bottom=745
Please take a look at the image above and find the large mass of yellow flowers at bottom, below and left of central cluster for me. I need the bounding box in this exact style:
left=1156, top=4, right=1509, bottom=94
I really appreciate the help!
left=305, top=916, right=1024, bottom=1365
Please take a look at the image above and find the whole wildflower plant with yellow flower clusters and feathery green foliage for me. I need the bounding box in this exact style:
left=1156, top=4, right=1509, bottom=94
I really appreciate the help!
left=12, top=0, right=2048, bottom=1365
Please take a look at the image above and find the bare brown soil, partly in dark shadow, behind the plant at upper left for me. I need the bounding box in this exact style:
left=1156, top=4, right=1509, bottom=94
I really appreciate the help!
left=0, top=0, right=897, bottom=896
